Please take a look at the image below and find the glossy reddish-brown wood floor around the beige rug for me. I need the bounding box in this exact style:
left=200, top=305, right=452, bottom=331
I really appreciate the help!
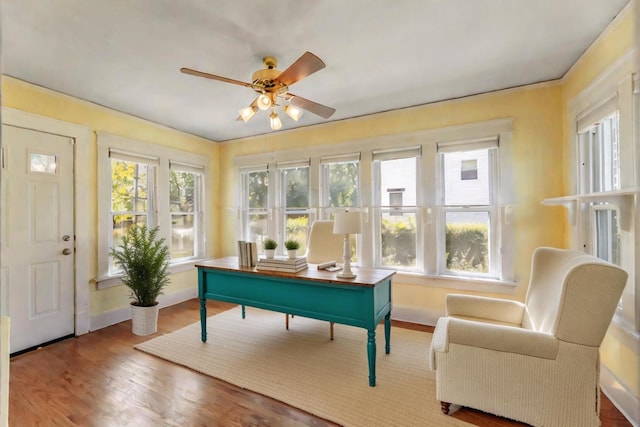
left=9, top=300, right=631, bottom=427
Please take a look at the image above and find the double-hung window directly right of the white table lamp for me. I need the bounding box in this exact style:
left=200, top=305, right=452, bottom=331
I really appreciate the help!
left=372, top=147, right=423, bottom=270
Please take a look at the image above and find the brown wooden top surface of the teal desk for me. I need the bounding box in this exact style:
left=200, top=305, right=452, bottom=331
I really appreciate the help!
left=195, top=257, right=396, bottom=286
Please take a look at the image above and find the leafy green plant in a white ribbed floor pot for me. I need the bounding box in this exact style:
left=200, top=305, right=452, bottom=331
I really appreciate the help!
left=110, top=225, right=169, bottom=335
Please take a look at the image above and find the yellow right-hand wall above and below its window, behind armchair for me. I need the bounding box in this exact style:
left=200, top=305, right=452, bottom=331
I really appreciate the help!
left=563, top=5, right=640, bottom=398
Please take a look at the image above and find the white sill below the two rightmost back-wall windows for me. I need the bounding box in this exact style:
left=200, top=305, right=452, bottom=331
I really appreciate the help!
left=394, top=271, right=518, bottom=295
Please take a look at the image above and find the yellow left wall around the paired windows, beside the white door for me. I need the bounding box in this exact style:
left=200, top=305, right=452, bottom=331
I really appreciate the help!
left=2, top=76, right=218, bottom=317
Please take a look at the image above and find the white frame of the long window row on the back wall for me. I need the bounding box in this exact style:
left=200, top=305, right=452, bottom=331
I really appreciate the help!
left=234, top=118, right=517, bottom=294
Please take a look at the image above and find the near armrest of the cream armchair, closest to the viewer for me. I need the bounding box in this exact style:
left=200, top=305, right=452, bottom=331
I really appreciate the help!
left=432, top=317, right=560, bottom=359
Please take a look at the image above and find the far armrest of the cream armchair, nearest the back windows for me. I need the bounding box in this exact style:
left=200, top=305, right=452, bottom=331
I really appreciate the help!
left=446, top=294, right=525, bottom=326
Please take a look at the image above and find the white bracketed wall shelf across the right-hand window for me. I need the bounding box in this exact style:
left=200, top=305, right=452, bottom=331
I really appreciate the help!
left=542, top=187, right=640, bottom=231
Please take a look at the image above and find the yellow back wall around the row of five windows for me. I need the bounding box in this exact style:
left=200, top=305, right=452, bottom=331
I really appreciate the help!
left=220, top=84, right=565, bottom=311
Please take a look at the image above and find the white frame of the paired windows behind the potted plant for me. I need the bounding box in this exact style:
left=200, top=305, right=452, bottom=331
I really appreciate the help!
left=95, top=132, right=210, bottom=289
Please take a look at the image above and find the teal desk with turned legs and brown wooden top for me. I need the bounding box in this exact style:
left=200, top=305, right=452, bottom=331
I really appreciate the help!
left=196, top=257, right=395, bottom=387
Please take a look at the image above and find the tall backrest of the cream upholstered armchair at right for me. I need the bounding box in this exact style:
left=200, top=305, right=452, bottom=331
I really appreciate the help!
left=523, top=248, right=627, bottom=347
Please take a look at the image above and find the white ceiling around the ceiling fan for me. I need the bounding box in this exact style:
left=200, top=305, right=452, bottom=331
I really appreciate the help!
left=0, top=0, right=628, bottom=141
